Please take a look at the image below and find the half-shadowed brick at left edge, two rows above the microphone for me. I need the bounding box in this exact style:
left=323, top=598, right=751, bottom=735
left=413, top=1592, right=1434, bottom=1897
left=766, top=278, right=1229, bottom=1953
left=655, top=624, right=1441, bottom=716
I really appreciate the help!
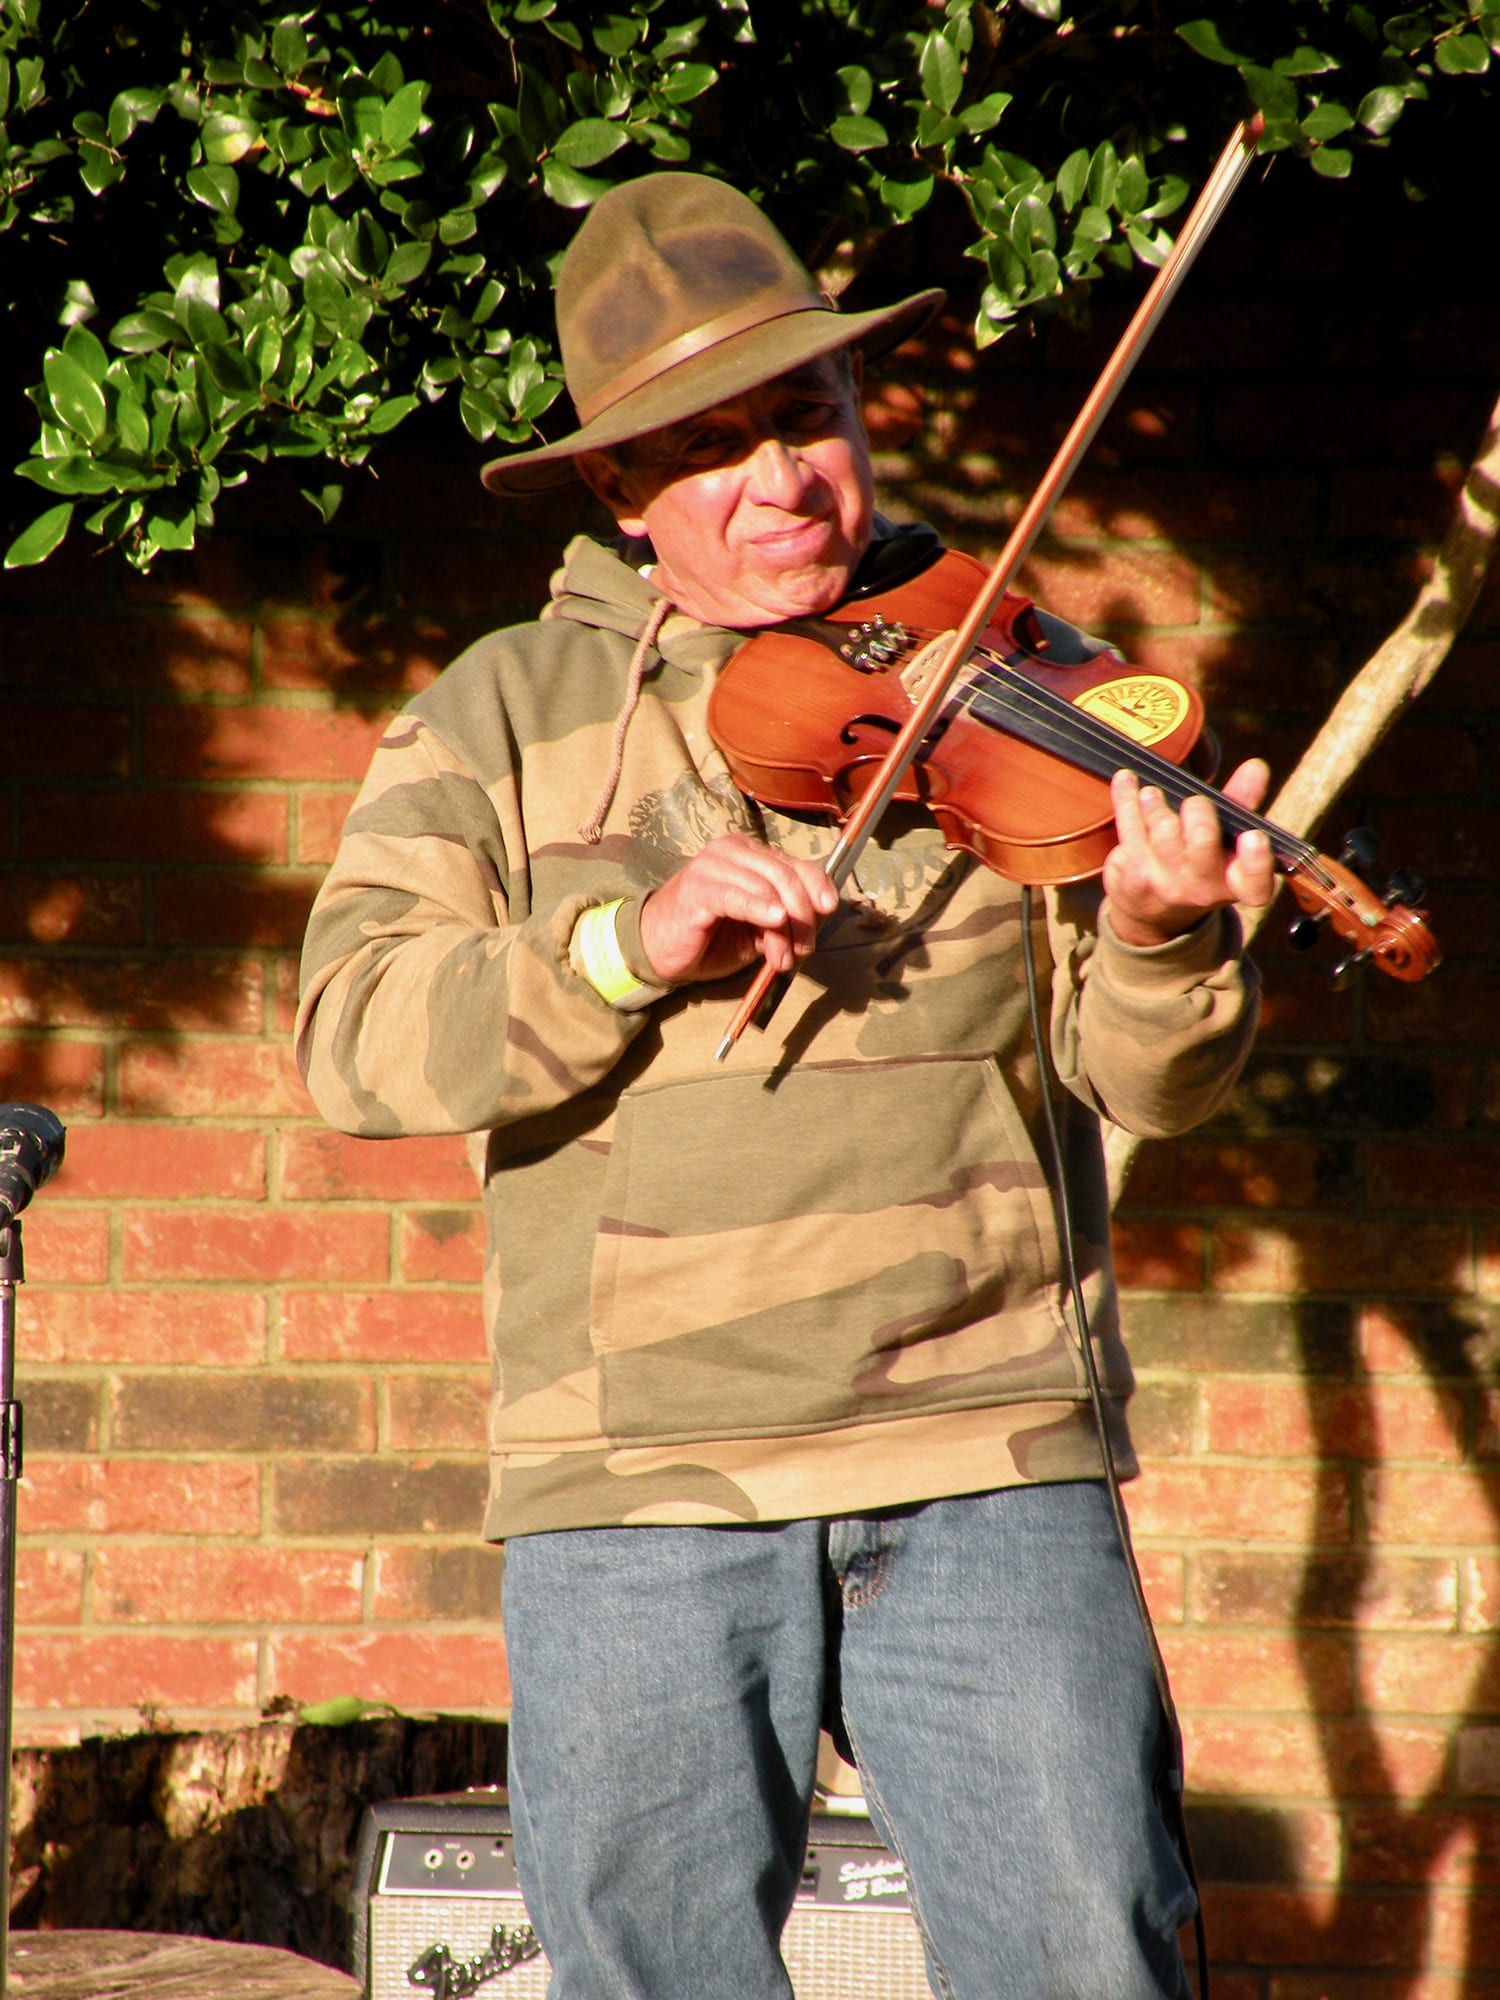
left=0, top=958, right=264, bottom=1034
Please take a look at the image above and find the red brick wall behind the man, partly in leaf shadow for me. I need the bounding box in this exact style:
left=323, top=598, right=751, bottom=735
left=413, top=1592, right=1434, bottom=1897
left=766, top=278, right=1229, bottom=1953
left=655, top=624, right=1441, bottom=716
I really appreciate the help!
left=0, top=168, right=1500, bottom=2000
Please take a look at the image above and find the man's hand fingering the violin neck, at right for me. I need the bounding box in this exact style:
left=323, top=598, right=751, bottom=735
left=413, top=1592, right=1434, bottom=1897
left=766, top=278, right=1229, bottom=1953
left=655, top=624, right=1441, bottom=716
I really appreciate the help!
left=1104, top=758, right=1276, bottom=946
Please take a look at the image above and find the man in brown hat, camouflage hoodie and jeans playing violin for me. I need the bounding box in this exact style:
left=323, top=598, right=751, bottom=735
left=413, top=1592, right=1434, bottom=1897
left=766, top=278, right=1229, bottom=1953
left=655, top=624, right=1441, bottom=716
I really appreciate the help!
left=300, top=174, right=1272, bottom=2000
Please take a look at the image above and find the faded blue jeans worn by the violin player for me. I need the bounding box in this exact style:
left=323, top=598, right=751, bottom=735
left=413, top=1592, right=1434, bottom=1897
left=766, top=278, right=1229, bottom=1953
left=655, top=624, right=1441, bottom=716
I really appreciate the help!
left=504, top=1482, right=1192, bottom=2000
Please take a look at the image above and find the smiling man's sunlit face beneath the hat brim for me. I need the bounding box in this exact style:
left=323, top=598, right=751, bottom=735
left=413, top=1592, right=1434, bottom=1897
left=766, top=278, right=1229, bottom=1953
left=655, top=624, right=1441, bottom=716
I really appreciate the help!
left=578, top=356, right=874, bottom=630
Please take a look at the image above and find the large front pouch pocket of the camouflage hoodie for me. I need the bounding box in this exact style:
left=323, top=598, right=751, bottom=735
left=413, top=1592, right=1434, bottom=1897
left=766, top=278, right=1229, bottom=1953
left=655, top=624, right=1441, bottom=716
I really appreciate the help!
left=592, top=1058, right=1078, bottom=1442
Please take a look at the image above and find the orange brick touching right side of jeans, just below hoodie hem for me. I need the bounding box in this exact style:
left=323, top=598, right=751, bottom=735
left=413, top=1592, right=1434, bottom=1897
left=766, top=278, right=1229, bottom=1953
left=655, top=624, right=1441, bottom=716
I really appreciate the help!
left=1126, top=1462, right=1350, bottom=1544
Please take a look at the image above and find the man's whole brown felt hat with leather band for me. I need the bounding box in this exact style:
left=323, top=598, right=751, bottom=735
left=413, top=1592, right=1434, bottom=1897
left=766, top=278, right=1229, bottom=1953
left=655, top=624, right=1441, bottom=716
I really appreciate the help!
left=482, top=174, right=944, bottom=494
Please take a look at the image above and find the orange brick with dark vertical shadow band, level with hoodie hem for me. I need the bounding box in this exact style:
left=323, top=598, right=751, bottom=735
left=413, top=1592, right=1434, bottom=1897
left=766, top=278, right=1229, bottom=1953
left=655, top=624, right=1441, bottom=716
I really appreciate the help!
left=1202, top=1380, right=1464, bottom=1464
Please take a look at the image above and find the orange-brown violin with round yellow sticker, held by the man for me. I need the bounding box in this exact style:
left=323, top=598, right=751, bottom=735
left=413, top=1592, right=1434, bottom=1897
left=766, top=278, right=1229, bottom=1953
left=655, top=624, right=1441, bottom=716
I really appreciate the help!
left=708, top=544, right=1442, bottom=980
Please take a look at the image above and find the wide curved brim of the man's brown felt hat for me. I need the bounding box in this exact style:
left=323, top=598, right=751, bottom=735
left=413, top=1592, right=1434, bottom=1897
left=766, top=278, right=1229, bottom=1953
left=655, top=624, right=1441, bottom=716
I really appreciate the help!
left=480, top=290, right=946, bottom=498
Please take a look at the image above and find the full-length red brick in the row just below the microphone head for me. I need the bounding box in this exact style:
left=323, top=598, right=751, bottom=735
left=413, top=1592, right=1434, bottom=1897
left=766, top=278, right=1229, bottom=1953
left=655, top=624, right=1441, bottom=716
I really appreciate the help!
left=124, top=1208, right=390, bottom=1284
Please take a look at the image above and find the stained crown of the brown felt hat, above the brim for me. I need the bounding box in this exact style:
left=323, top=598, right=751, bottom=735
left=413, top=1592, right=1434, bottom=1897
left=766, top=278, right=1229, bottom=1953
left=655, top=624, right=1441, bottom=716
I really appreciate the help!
left=558, top=174, right=826, bottom=420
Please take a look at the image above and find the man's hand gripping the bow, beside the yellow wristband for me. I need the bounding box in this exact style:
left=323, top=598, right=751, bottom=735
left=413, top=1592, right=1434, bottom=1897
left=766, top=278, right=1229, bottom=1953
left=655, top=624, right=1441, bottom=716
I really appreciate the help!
left=640, top=834, right=838, bottom=986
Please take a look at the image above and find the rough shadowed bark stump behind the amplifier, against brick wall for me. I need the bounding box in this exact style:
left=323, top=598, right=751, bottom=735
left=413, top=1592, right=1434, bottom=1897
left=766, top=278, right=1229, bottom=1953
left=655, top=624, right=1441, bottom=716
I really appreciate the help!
left=10, top=1716, right=506, bottom=1990
